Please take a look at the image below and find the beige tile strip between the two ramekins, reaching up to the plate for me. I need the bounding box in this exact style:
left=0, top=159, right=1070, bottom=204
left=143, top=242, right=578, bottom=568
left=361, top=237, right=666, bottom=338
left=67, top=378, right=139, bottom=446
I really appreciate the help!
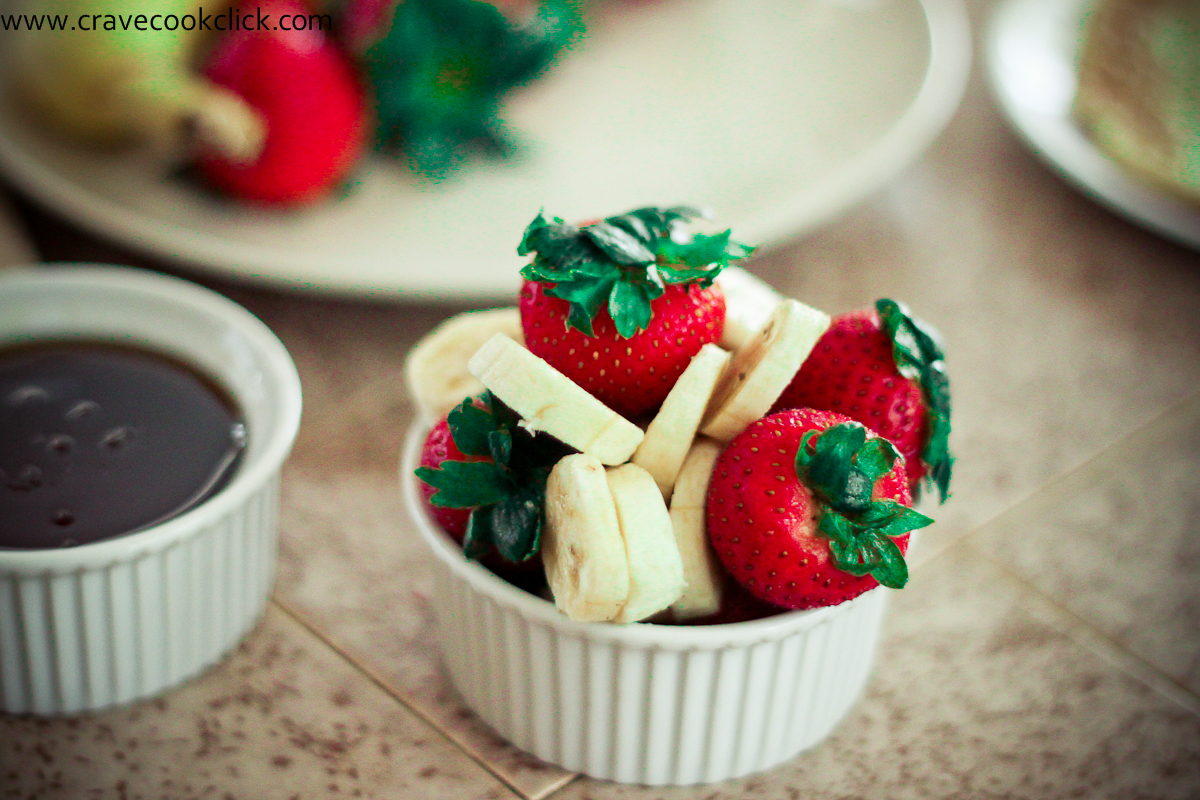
left=246, top=294, right=570, bottom=798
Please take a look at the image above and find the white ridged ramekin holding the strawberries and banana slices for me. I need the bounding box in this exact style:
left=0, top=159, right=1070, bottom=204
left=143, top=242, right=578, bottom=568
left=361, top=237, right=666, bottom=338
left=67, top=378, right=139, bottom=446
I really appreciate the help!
left=401, top=426, right=889, bottom=786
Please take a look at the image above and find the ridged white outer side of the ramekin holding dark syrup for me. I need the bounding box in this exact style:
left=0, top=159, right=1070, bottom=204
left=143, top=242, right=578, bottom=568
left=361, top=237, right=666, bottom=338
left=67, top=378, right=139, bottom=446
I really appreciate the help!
left=0, top=476, right=280, bottom=714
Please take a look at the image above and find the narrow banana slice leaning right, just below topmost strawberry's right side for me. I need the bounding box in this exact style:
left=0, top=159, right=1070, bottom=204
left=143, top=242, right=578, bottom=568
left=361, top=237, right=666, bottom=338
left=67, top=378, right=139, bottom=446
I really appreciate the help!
left=634, top=344, right=730, bottom=500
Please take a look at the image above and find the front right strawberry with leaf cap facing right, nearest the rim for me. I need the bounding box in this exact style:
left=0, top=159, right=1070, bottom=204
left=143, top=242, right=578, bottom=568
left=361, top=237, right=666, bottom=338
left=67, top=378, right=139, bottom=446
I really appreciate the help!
left=707, top=409, right=932, bottom=608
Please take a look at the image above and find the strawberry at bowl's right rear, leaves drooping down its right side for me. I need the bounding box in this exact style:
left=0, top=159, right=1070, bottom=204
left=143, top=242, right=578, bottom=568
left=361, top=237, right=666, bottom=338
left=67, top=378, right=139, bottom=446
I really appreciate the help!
left=772, top=300, right=953, bottom=503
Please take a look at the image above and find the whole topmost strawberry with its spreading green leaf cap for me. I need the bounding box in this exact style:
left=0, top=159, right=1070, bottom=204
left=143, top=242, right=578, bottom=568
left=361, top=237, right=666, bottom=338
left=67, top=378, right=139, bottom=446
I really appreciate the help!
left=517, top=207, right=752, bottom=417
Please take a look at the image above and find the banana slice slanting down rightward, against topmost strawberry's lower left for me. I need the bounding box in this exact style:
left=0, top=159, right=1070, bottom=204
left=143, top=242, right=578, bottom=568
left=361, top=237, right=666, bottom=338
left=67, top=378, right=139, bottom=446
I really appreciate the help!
left=467, top=333, right=643, bottom=464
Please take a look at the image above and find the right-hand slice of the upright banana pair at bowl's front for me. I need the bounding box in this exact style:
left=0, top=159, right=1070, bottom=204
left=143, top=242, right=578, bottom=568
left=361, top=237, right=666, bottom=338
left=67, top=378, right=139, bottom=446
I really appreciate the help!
left=608, top=464, right=684, bottom=622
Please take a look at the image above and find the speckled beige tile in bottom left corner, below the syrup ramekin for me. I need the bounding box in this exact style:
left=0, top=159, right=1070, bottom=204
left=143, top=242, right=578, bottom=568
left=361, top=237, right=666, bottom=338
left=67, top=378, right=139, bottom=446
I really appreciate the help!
left=0, top=607, right=515, bottom=800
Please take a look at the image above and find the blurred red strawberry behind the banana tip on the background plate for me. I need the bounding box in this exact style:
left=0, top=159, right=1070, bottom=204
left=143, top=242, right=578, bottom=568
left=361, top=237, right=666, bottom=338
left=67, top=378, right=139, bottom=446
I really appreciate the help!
left=198, top=0, right=367, bottom=204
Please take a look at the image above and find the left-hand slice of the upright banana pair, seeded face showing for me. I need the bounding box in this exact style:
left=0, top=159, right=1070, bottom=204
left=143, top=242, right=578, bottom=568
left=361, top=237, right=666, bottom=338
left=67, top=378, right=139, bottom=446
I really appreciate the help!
left=541, top=453, right=630, bottom=622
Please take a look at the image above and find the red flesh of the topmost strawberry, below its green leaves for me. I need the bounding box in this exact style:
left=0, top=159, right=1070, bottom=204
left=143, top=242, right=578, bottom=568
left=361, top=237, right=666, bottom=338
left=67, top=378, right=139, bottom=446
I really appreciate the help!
left=521, top=281, right=725, bottom=417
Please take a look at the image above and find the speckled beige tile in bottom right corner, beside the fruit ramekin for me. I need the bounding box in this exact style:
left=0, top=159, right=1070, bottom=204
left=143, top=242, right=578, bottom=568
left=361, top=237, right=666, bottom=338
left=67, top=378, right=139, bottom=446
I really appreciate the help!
left=556, top=546, right=1200, bottom=800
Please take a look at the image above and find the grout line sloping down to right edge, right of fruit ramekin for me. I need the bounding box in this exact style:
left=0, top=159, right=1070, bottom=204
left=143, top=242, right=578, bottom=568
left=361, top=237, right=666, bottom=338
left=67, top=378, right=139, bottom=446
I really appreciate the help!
left=955, top=541, right=1200, bottom=715
